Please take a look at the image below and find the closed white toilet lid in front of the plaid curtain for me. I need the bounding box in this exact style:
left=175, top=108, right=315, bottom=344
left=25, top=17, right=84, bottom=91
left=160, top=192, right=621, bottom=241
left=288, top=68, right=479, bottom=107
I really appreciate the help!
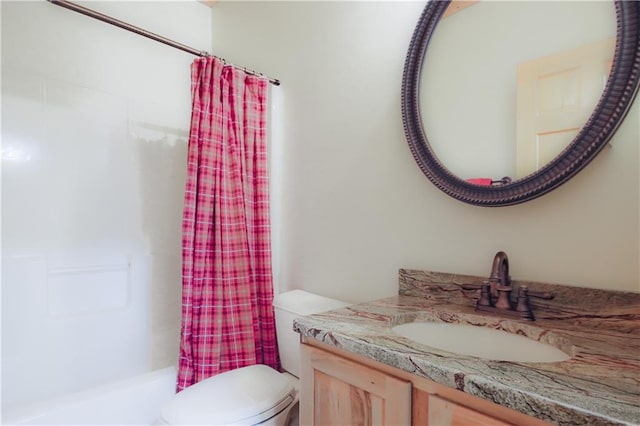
left=161, top=365, right=295, bottom=425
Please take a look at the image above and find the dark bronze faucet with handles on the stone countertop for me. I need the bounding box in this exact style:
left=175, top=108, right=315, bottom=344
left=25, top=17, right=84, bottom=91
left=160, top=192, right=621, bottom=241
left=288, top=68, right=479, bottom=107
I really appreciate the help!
left=476, top=251, right=553, bottom=321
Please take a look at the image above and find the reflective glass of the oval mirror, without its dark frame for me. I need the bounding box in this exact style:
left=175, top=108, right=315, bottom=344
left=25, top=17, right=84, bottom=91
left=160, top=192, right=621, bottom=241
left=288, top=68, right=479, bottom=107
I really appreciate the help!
left=420, top=1, right=616, bottom=180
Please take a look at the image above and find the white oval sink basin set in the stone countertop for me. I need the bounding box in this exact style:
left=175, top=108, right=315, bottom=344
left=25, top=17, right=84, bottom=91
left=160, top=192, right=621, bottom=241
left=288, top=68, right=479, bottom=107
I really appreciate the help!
left=392, top=322, right=571, bottom=362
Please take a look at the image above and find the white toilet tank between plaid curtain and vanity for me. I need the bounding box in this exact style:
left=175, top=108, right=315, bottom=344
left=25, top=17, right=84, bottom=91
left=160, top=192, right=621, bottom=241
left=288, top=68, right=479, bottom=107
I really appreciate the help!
left=273, top=290, right=349, bottom=377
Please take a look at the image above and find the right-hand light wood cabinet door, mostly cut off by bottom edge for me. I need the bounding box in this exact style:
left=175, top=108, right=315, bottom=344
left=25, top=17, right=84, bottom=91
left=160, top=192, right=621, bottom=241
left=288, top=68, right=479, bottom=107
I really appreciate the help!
left=427, top=395, right=511, bottom=426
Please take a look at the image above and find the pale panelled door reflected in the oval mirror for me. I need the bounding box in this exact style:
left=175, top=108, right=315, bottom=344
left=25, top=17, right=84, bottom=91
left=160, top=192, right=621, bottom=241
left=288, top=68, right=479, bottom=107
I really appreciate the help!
left=515, top=38, right=616, bottom=178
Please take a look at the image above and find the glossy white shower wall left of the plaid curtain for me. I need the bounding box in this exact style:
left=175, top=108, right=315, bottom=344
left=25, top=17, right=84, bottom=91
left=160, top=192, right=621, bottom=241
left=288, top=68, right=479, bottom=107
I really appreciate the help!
left=2, top=1, right=211, bottom=405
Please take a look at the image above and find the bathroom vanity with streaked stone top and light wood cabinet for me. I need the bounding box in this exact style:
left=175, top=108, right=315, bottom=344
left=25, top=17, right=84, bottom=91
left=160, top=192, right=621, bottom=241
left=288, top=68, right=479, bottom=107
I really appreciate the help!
left=294, top=270, right=640, bottom=426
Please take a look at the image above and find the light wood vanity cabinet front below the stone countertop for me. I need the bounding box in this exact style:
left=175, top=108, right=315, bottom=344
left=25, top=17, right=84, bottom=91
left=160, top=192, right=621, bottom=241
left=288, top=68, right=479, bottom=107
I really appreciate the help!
left=300, top=342, right=550, bottom=426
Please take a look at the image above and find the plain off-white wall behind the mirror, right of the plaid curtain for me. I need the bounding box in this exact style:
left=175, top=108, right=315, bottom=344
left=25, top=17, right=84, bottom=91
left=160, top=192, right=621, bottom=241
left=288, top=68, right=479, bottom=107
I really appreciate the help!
left=213, top=2, right=640, bottom=301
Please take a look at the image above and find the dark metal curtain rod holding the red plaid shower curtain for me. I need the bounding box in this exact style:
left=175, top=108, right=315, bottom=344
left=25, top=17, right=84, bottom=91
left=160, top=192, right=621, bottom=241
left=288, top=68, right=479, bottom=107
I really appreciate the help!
left=47, top=0, right=280, bottom=86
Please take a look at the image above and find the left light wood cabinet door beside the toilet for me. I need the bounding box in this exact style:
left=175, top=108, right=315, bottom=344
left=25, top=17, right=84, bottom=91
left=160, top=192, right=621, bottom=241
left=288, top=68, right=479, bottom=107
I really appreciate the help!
left=300, top=345, right=411, bottom=426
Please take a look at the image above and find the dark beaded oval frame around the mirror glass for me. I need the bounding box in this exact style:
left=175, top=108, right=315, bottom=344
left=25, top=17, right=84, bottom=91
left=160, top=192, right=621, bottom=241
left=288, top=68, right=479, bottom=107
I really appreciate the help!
left=402, top=0, right=640, bottom=207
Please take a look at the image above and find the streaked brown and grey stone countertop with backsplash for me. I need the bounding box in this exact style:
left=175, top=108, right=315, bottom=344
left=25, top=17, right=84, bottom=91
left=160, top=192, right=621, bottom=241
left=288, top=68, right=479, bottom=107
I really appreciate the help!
left=294, top=270, right=640, bottom=425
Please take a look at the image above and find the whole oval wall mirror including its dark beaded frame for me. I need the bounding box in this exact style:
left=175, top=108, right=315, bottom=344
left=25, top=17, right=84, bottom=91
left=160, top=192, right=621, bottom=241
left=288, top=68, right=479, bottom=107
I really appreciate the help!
left=402, top=1, right=640, bottom=206
